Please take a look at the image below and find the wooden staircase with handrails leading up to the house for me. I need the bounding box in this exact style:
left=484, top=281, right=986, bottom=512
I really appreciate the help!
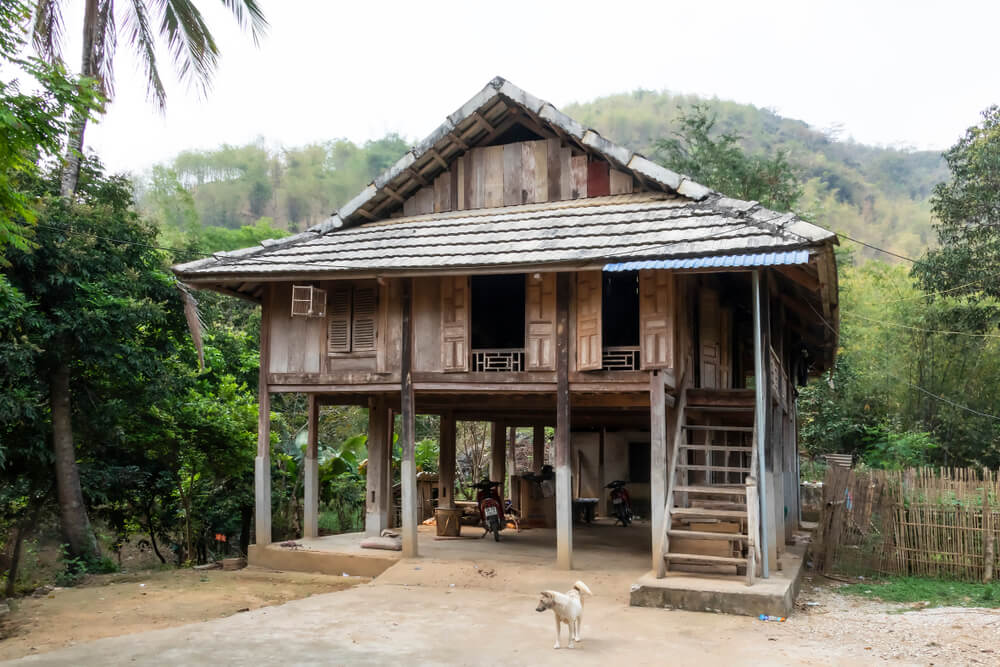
left=662, top=389, right=760, bottom=585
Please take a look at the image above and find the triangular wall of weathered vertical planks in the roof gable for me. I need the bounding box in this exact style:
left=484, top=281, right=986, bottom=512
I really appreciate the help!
left=400, top=139, right=633, bottom=215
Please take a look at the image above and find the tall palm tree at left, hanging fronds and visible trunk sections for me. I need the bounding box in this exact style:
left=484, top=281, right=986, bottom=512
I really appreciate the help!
left=32, top=0, right=267, bottom=560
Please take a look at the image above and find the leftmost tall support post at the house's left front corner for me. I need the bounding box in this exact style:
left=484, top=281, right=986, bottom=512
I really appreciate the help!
left=254, top=290, right=271, bottom=546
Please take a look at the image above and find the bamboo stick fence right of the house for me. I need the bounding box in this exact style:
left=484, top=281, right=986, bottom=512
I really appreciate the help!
left=816, top=466, right=1000, bottom=581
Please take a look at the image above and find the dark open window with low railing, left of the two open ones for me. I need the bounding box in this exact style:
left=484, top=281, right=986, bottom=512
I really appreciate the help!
left=469, top=274, right=525, bottom=372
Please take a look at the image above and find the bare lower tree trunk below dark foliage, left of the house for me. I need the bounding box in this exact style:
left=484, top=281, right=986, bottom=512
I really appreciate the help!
left=49, top=362, right=97, bottom=561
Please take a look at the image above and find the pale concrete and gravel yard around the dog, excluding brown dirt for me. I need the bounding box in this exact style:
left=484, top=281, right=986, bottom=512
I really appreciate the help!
left=4, top=558, right=1000, bottom=667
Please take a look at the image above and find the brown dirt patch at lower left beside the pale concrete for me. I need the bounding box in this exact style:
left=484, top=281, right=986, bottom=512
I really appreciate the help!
left=0, top=568, right=362, bottom=660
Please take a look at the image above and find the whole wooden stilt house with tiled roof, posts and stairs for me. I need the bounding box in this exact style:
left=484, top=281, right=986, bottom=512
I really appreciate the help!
left=174, top=78, right=838, bottom=580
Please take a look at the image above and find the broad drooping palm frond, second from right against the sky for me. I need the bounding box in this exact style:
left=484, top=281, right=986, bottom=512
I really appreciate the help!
left=157, top=0, right=219, bottom=94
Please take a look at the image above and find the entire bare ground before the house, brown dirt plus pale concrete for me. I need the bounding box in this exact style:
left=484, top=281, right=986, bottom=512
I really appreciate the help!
left=0, top=559, right=1000, bottom=667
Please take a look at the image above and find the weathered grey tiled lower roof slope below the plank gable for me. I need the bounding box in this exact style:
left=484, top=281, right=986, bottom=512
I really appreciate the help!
left=175, top=193, right=834, bottom=280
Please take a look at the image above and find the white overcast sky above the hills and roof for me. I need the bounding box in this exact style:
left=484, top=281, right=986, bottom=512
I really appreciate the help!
left=65, top=0, right=1000, bottom=175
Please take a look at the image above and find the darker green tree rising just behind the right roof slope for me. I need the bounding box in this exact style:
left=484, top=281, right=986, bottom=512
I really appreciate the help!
left=656, top=104, right=802, bottom=211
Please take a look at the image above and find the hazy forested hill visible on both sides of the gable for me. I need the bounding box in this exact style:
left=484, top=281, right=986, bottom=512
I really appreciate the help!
left=138, top=91, right=944, bottom=256
